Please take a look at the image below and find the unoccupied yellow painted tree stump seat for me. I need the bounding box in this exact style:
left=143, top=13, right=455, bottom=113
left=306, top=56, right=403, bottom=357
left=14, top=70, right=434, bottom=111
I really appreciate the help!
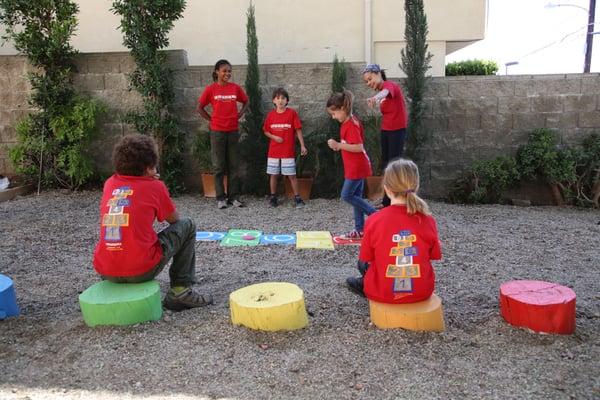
left=229, top=282, right=308, bottom=331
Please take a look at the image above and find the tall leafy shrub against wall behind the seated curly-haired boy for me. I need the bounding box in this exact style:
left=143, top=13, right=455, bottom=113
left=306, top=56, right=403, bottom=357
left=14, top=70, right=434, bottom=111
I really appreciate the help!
left=112, top=0, right=186, bottom=193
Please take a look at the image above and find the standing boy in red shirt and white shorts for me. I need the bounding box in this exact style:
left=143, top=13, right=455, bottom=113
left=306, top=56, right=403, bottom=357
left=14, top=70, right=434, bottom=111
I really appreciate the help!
left=263, top=88, right=308, bottom=208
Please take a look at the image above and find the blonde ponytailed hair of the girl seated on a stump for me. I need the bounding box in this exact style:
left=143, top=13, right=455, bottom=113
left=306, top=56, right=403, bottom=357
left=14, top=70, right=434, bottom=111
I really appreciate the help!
left=383, top=158, right=431, bottom=215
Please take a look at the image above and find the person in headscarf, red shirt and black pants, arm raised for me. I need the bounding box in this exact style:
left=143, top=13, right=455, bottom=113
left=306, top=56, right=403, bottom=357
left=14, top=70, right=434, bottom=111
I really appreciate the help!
left=363, top=64, right=407, bottom=207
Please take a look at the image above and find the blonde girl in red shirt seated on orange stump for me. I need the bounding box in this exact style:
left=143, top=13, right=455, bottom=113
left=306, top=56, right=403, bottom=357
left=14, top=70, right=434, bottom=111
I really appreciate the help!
left=346, top=158, right=442, bottom=303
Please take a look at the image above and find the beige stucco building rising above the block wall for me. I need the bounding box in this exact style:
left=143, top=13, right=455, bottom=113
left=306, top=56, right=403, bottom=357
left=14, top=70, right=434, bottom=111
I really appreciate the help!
left=0, top=0, right=487, bottom=77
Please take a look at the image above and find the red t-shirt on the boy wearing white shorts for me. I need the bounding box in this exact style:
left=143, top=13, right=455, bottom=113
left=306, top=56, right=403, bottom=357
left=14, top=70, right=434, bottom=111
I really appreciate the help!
left=263, top=108, right=302, bottom=158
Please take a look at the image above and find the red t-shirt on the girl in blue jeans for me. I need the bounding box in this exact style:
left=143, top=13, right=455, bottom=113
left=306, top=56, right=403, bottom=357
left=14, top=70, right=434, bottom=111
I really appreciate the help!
left=340, top=116, right=372, bottom=179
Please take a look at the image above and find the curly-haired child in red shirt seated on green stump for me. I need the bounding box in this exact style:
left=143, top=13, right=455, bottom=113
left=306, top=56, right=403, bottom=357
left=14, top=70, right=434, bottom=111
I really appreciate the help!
left=93, top=134, right=212, bottom=311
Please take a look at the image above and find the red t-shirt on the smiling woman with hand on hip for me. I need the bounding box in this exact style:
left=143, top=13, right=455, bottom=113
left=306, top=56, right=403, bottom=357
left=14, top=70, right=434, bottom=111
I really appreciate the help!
left=198, top=82, right=248, bottom=132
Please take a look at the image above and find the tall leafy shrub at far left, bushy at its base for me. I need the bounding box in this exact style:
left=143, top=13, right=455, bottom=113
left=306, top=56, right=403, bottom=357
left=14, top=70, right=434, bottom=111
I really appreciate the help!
left=0, top=0, right=103, bottom=190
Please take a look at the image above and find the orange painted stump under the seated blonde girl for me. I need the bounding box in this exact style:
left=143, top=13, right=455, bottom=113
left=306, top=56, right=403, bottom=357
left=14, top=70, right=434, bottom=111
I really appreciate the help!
left=369, top=294, right=445, bottom=332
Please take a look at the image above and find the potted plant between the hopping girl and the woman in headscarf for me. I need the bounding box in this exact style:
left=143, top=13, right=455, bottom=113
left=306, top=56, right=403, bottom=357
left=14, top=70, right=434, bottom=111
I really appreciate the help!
left=363, top=115, right=383, bottom=201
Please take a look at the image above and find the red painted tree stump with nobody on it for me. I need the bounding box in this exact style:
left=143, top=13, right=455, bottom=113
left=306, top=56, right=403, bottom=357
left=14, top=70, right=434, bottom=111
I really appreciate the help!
left=500, top=281, right=576, bottom=334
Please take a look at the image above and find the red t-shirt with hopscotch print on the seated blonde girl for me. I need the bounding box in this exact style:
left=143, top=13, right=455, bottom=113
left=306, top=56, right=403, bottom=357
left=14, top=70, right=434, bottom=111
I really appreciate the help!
left=359, top=205, right=442, bottom=303
